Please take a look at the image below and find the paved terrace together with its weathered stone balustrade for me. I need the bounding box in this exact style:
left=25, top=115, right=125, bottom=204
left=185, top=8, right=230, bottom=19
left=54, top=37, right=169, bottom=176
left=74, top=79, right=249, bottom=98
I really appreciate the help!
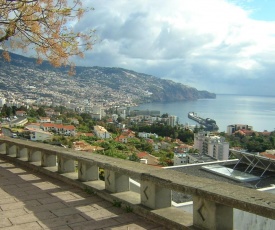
left=0, top=138, right=275, bottom=229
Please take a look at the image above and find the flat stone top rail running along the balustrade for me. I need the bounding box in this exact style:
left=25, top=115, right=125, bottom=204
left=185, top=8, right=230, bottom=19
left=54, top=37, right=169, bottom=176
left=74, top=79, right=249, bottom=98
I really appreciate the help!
left=0, top=138, right=275, bottom=228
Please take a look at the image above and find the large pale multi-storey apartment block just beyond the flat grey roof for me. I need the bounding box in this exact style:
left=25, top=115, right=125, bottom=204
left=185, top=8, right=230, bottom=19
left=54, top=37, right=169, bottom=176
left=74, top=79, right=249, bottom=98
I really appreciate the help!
left=194, top=131, right=229, bottom=160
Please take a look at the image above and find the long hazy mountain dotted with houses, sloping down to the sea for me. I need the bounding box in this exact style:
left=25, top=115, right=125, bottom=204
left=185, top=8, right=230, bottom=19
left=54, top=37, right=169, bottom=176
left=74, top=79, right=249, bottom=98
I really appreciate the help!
left=0, top=53, right=216, bottom=103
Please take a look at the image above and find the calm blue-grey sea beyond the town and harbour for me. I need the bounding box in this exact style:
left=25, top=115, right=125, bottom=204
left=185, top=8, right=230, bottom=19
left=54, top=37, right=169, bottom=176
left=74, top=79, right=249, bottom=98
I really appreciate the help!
left=131, top=94, right=275, bottom=132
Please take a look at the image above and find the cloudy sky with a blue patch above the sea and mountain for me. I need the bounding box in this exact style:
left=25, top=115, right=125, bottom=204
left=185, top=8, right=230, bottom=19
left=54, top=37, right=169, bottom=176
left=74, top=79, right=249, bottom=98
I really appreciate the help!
left=71, top=0, right=275, bottom=95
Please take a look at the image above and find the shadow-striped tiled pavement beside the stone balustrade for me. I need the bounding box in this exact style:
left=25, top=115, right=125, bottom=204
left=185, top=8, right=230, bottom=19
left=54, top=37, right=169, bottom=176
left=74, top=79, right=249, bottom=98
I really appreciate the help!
left=0, top=160, right=166, bottom=230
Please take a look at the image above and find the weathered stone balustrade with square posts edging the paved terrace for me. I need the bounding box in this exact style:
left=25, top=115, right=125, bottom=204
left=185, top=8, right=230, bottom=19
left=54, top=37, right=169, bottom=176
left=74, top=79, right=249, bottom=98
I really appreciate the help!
left=0, top=138, right=275, bottom=229
